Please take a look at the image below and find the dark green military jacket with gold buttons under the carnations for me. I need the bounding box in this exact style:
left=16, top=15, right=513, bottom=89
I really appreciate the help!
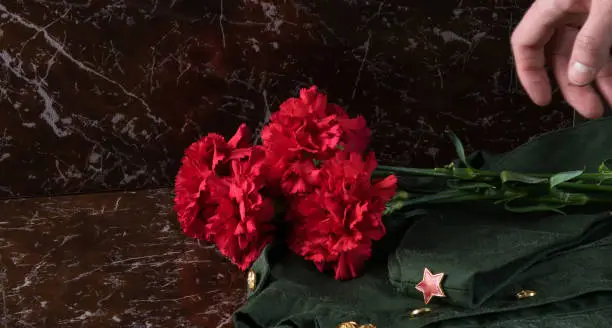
left=234, top=118, right=612, bottom=328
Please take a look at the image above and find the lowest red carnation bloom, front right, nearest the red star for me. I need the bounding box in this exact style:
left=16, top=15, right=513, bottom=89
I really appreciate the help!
left=289, top=152, right=397, bottom=280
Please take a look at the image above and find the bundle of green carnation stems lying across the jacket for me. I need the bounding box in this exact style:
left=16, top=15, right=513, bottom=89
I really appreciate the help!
left=375, top=166, right=612, bottom=213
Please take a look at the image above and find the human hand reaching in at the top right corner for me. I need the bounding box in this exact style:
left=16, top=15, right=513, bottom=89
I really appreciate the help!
left=511, top=0, right=612, bottom=118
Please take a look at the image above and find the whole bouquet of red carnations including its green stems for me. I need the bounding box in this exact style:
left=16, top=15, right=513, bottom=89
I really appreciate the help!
left=175, top=86, right=612, bottom=280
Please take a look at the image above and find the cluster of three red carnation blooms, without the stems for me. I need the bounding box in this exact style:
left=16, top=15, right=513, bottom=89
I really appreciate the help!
left=175, top=86, right=396, bottom=279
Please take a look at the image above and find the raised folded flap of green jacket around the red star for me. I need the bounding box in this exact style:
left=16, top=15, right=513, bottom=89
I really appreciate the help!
left=388, top=207, right=612, bottom=308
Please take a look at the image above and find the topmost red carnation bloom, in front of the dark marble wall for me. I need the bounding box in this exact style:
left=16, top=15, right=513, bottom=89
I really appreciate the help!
left=262, top=86, right=370, bottom=195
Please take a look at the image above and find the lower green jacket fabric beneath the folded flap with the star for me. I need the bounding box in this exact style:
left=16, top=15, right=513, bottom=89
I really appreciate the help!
left=234, top=232, right=612, bottom=328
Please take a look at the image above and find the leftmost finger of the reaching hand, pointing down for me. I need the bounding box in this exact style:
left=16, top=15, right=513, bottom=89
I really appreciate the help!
left=511, top=0, right=567, bottom=106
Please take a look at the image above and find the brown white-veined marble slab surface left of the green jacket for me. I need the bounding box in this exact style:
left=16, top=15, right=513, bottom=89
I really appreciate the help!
left=0, top=189, right=246, bottom=328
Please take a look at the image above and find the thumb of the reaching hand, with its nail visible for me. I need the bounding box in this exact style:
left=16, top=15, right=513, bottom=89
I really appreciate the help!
left=568, top=4, right=612, bottom=86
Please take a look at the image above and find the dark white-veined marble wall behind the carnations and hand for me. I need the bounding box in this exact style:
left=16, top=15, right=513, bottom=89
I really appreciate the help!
left=0, top=0, right=571, bottom=198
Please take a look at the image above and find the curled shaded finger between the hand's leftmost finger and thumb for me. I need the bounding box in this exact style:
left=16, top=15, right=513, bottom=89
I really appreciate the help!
left=551, top=28, right=603, bottom=118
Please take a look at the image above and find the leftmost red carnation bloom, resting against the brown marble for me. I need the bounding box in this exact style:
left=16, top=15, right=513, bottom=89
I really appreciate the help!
left=174, top=124, right=274, bottom=270
